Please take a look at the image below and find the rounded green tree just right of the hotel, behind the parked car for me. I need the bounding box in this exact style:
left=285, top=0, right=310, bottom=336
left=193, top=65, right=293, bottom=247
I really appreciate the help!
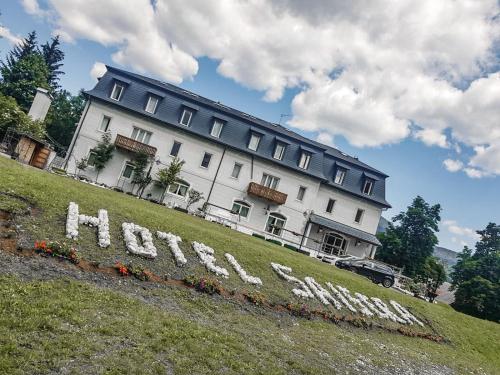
left=376, top=196, right=441, bottom=277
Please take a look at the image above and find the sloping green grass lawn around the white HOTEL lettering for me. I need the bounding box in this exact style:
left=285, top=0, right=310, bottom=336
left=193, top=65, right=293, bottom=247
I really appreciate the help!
left=0, top=158, right=500, bottom=374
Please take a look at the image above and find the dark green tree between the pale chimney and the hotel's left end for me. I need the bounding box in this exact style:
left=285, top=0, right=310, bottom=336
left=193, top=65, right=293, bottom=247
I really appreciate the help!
left=45, top=90, right=85, bottom=154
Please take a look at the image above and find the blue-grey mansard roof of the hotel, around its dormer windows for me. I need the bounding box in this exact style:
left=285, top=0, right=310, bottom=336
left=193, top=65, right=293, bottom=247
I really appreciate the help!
left=86, top=66, right=390, bottom=207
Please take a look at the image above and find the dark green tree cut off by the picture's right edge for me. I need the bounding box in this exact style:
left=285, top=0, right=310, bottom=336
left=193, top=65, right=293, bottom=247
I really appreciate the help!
left=451, top=223, right=500, bottom=322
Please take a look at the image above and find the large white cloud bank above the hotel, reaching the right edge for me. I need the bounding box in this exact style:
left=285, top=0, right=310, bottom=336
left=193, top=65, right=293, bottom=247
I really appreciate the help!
left=23, top=0, right=500, bottom=177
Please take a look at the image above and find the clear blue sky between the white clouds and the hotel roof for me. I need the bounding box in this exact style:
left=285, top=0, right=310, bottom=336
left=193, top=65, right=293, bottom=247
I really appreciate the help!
left=0, top=1, right=500, bottom=250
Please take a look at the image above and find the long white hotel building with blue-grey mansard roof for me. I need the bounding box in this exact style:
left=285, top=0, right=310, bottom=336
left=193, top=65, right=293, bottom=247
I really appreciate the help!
left=66, top=67, right=390, bottom=257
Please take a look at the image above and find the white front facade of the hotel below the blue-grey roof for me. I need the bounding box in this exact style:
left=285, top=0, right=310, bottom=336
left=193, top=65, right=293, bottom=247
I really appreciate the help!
left=67, top=100, right=382, bottom=257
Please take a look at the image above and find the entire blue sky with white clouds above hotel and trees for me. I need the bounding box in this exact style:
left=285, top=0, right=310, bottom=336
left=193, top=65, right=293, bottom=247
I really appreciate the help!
left=0, top=0, right=500, bottom=250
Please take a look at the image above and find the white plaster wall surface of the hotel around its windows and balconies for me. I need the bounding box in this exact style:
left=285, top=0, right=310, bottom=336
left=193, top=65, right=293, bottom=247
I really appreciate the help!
left=67, top=102, right=381, bottom=253
